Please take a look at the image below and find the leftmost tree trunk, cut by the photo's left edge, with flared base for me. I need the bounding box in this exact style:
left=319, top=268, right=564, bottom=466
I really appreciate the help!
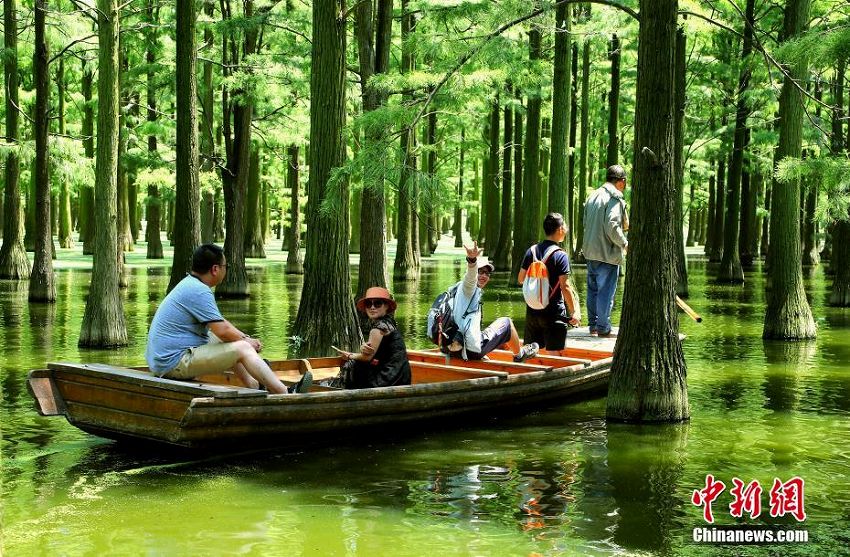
left=0, top=0, right=30, bottom=280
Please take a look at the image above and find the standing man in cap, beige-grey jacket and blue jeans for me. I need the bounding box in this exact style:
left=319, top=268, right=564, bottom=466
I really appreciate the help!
left=582, top=164, right=629, bottom=337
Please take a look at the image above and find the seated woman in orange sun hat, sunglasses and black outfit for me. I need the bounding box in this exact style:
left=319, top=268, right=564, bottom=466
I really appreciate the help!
left=332, top=286, right=410, bottom=389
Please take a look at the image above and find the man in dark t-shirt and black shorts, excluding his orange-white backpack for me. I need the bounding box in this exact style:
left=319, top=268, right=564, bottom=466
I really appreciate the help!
left=517, top=213, right=581, bottom=355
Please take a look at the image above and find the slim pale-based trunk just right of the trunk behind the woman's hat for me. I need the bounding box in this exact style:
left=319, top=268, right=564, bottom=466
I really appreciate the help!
left=393, top=0, right=419, bottom=281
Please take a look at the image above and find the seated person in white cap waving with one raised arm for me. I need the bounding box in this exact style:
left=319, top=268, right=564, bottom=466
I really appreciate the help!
left=438, top=242, right=537, bottom=362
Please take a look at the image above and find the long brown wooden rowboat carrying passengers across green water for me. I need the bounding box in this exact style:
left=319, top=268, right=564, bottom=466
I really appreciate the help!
left=28, top=348, right=611, bottom=448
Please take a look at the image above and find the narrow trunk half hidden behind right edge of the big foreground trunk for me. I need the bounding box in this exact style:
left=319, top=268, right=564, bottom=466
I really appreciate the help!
left=673, top=27, right=688, bottom=298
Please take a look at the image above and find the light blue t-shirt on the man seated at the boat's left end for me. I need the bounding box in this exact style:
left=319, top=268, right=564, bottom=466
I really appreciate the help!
left=145, top=275, right=224, bottom=375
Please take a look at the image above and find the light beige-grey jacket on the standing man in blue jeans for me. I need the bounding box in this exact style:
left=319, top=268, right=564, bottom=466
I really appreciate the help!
left=582, top=182, right=629, bottom=265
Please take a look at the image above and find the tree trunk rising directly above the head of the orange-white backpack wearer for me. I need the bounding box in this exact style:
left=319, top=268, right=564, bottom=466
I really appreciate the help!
left=547, top=4, right=572, bottom=216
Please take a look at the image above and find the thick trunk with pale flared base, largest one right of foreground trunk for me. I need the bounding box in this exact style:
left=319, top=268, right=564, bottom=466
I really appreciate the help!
left=762, top=0, right=817, bottom=340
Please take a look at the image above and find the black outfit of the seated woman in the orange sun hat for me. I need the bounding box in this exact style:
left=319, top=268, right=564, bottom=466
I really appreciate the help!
left=346, top=315, right=410, bottom=389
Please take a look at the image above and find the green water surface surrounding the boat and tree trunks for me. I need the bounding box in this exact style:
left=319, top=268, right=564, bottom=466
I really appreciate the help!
left=0, top=248, right=850, bottom=557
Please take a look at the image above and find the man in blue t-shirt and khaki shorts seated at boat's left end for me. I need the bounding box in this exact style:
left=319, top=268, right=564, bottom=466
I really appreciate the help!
left=145, top=244, right=312, bottom=394
